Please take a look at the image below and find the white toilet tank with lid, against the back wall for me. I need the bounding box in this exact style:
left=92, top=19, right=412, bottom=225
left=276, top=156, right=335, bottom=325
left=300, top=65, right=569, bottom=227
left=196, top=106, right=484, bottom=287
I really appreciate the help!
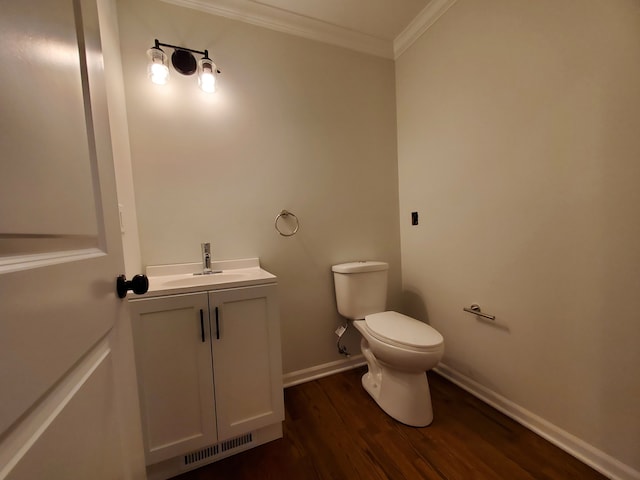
left=331, top=261, right=389, bottom=320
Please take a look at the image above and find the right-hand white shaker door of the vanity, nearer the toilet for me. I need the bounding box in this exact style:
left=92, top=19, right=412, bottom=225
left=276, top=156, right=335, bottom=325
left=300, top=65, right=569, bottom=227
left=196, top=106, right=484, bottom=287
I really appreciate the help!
left=209, top=285, right=284, bottom=440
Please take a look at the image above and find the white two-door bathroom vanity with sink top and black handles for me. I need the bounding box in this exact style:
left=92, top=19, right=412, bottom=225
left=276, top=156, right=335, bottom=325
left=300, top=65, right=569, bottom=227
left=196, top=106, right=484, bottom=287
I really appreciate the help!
left=129, top=259, right=284, bottom=479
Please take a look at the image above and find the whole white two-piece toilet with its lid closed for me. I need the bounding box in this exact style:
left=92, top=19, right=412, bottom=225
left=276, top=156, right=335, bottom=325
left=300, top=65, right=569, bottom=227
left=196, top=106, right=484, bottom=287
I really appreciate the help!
left=331, top=261, right=444, bottom=427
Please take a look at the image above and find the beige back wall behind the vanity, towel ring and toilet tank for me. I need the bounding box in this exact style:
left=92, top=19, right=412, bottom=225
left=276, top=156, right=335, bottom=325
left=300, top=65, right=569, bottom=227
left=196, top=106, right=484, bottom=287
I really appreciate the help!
left=118, top=0, right=400, bottom=373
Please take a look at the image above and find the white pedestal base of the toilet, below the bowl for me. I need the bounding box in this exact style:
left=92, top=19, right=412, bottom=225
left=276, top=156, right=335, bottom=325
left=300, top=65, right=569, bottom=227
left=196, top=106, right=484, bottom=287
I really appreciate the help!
left=362, top=362, right=433, bottom=427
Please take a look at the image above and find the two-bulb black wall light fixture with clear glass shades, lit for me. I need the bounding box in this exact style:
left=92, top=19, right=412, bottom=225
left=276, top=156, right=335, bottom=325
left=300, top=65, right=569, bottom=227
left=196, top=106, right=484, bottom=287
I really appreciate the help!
left=147, top=39, right=220, bottom=93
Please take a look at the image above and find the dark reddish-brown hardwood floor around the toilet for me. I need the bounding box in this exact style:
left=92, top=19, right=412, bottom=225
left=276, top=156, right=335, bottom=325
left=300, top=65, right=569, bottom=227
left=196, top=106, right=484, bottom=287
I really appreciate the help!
left=175, top=367, right=606, bottom=480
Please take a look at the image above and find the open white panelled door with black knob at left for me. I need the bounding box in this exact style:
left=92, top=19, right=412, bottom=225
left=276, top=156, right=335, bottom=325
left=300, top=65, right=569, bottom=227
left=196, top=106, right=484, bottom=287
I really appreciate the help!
left=0, top=0, right=144, bottom=480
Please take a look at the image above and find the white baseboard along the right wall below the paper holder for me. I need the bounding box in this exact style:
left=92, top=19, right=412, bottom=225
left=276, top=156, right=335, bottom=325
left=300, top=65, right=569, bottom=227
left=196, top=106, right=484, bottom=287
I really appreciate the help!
left=434, top=363, right=640, bottom=480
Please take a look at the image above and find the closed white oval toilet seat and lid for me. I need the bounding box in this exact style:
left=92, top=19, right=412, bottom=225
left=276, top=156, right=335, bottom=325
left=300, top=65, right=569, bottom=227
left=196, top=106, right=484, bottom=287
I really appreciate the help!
left=365, top=311, right=444, bottom=352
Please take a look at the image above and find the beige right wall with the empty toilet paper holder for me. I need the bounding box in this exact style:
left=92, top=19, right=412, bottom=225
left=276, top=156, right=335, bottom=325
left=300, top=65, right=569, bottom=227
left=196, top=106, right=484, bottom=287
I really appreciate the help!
left=396, top=0, right=640, bottom=472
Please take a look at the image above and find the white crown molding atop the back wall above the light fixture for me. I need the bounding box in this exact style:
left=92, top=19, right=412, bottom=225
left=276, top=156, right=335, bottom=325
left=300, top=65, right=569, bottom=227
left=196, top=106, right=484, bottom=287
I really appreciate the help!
left=162, top=0, right=394, bottom=59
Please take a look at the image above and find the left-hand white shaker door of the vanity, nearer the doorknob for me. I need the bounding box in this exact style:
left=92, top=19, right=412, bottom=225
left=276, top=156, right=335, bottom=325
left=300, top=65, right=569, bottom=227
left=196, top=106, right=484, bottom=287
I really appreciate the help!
left=129, top=293, right=217, bottom=465
